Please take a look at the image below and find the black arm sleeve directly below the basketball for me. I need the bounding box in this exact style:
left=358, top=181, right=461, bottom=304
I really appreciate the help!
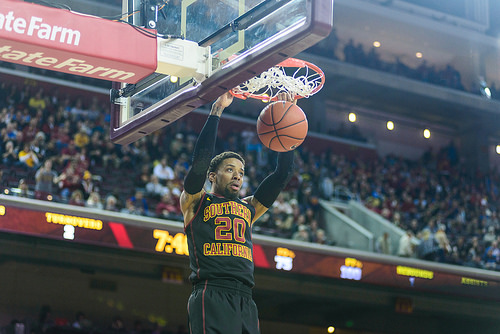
left=254, top=151, right=294, bottom=208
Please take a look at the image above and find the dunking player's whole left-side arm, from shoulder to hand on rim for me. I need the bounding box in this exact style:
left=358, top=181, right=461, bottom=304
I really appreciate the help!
left=180, top=92, right=233, bottom=225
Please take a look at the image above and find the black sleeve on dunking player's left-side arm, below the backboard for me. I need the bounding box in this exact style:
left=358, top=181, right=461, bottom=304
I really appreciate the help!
left=184, top=115, right=219, bottom=195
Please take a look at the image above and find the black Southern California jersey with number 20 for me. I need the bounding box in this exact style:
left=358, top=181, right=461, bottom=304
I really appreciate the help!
left=185, top=193, right=255, bottom=287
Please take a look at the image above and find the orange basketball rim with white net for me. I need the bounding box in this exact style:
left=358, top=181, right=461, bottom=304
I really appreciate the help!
left=230, top=58, right=325, bottom=102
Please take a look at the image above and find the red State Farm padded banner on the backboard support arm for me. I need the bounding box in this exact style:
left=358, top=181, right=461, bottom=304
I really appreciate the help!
left=0, top=0, right=156, bottom=83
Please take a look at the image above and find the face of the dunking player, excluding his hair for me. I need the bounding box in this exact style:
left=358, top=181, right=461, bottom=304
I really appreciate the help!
left=212, top=158, right=245, bottom=199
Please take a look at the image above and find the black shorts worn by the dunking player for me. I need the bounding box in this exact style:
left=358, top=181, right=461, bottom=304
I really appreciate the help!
left=188, top=279, right=260, bottom=334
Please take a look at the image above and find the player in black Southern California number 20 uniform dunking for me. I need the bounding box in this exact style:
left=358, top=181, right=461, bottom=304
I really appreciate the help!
left=180, top=93, right=294, bottom=334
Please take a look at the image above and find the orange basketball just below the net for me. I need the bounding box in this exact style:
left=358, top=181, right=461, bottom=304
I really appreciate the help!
left=257, top=101, right=308, bottom=152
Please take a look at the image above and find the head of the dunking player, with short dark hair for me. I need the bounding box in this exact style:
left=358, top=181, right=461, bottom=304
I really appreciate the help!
left=208, top=152, right=245, bottom=199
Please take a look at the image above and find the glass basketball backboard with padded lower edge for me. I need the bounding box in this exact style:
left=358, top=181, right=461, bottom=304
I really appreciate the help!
left=110, top=0, right=333, bottom=144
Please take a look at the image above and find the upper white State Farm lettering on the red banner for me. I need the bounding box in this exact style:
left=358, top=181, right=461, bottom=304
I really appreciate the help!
left=0, top=11, right=80, bottom=46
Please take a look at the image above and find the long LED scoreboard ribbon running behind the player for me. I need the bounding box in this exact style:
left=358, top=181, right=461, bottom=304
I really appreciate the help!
left=0, top=195, right=500, bottom=301
